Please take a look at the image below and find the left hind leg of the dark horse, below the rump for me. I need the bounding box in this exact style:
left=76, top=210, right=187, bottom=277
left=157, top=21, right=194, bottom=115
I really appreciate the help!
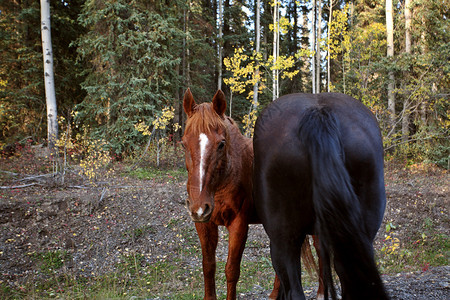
left=270, top=236, right=306, bottom=300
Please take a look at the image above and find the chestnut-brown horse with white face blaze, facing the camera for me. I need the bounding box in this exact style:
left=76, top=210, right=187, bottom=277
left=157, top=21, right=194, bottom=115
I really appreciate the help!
left=183, top=89, right=323, bottom=299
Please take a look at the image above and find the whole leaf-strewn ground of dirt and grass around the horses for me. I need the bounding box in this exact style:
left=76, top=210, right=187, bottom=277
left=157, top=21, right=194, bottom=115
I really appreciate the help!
left=0, top=151, right=450, bottom=299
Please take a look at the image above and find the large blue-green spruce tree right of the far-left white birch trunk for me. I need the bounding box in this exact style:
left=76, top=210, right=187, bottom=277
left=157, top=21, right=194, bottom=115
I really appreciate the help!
left=77, top=1, right=181, bottom=153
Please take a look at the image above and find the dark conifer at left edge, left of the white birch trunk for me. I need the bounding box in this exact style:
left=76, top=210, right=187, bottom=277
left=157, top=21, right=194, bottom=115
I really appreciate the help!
left=0, top=0, right=47, bottom=142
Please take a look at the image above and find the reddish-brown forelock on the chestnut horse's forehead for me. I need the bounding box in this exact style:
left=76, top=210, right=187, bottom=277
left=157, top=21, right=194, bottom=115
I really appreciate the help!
left=185, top=103, right=226, bottom=135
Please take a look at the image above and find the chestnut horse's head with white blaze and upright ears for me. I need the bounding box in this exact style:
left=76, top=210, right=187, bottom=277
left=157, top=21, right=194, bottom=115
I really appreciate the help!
left=183, top=89, right=228, bottom=222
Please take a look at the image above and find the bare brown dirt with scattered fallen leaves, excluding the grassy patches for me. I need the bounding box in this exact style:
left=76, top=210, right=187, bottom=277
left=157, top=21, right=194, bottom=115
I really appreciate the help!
left=0, top=159, right=450, bottom=299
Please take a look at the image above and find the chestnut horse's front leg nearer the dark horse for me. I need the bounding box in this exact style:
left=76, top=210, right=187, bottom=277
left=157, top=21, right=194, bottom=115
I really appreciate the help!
left=225, top=218, right=248, bottom=300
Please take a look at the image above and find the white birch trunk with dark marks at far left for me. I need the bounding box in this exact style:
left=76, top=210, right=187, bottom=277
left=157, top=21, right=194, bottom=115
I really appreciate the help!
left=41, top=0, right=58, bottom=156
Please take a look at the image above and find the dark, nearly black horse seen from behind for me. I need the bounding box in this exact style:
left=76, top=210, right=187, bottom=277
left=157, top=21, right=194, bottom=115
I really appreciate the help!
left=253, top=93, right=388, bottom=299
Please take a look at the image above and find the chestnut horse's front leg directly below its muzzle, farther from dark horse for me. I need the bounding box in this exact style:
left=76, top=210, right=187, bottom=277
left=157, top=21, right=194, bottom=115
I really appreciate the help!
left=195, top=222, right=219, bottom=300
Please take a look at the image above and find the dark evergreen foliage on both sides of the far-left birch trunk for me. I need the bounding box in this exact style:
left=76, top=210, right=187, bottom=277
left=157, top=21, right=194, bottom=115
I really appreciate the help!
left=0, top=0, right=84, bottom=143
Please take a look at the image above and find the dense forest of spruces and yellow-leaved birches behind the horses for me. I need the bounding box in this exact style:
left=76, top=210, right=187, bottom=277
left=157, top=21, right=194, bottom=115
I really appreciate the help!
left=0, top=0, right=450, bottom=168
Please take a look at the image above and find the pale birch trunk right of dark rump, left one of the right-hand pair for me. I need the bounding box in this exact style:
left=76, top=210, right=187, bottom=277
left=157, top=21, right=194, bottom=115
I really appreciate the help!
left=386, top=0, right=395, bottom=126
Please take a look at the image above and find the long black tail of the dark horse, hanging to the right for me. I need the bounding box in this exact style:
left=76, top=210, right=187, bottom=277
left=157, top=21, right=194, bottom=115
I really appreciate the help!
left=299, top=107, right=388, bottom=299
